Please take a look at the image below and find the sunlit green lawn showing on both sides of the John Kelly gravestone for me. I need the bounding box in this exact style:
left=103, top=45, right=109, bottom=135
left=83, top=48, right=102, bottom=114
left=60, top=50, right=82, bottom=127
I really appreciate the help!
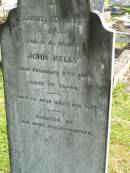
left=0, top=71, right=130, bottom=173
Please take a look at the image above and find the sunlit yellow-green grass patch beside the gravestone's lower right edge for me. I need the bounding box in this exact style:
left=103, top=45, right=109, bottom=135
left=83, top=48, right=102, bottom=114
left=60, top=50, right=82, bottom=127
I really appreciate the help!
left=109, top=83, right=130, bottom=173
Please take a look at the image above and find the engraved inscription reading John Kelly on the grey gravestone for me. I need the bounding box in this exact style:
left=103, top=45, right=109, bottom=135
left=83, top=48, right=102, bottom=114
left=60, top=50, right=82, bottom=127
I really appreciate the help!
left=16, top=0, right=94, bottom=138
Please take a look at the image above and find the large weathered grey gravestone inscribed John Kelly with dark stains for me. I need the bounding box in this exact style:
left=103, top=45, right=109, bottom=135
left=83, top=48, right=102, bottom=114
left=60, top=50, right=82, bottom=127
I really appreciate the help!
left=1, top=0, right=113, bottom=173
